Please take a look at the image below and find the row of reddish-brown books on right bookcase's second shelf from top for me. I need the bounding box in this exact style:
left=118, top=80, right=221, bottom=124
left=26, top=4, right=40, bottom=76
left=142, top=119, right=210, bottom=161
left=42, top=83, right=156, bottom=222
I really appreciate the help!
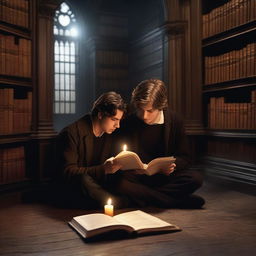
left=204, top=43, right=256, bottom=85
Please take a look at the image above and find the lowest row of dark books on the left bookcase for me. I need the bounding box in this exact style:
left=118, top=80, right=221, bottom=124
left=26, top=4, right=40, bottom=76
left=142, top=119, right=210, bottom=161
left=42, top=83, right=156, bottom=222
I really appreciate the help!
left=0, top=146, right=26, bottom=184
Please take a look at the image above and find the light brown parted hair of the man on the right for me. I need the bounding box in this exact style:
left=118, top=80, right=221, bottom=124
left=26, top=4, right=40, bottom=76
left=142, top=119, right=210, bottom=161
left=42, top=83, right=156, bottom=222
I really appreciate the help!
left=131, top=78, right=168, bottom=110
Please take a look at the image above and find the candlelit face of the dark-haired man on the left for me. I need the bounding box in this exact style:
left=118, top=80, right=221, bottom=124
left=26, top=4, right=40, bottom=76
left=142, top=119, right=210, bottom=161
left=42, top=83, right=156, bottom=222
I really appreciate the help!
left=100, top=109, right=124, bottom=134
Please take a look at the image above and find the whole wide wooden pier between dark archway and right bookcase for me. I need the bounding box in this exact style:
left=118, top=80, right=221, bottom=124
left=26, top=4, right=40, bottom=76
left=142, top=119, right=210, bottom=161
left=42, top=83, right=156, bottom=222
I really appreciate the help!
left=164, top=0, right=203, bottom=135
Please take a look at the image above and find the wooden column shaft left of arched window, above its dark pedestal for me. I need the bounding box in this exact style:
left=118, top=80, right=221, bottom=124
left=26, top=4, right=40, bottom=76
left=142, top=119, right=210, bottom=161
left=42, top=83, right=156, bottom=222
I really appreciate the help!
left=36, top=1, right=57, bottom=137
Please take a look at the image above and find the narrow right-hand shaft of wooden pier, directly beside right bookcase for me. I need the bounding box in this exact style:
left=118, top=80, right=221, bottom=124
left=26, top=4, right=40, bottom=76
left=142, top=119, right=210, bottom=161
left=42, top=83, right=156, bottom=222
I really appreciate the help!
left=183, top=0, right=204, bottom=135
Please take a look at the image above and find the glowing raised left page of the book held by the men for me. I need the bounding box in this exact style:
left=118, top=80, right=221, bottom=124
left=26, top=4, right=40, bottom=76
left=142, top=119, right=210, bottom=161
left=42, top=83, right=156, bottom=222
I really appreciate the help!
left=115, top=151, right=144, bottom=170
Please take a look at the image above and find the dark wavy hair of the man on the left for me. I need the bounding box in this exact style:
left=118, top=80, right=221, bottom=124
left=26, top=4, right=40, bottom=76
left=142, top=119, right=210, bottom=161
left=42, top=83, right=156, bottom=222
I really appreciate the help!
left=91, top=92, right=126, bottom=118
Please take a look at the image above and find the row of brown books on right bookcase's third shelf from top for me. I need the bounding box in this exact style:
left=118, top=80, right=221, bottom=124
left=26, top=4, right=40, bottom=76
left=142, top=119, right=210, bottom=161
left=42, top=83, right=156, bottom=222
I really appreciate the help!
left=208, top=91, right=256, bottom=130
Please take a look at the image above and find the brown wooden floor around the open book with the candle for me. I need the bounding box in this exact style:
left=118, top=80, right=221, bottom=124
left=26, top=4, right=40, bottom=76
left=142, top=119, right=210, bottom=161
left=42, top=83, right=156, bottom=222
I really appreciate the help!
left=0, top=178, right=256, bottom=256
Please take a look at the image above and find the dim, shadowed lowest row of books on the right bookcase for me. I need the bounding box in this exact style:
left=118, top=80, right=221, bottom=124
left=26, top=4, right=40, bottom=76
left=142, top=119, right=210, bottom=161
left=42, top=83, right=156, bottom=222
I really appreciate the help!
left=207, top=139, right=256, bottom=163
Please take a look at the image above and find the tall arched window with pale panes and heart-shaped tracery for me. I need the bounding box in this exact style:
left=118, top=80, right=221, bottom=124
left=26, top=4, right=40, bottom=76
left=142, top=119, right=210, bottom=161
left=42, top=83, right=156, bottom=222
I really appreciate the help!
left=53, top=2, right=78, bottom=114
